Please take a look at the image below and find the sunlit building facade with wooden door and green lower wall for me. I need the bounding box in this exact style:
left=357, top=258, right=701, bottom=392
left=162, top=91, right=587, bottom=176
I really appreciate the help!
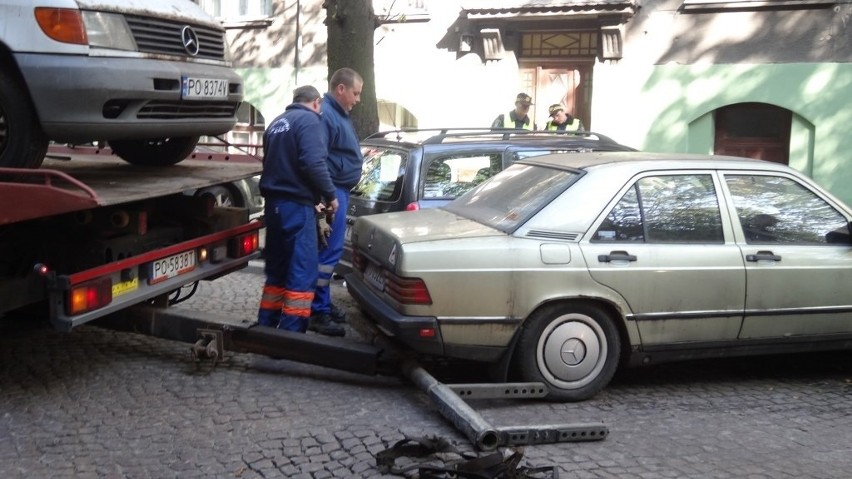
left=205, top=0, right=852, bottom=203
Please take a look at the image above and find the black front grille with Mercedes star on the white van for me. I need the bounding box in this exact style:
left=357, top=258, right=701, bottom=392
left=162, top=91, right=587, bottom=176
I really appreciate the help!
left=125, top=15, right=225, bottom=60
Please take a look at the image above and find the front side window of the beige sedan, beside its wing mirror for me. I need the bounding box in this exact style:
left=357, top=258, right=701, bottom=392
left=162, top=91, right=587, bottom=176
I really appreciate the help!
left=725, top=175, right=848, bottom=245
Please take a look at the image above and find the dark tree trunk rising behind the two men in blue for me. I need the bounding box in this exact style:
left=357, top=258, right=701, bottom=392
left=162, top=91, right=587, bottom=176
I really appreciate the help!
left=323, top=0, right=379, bottom=138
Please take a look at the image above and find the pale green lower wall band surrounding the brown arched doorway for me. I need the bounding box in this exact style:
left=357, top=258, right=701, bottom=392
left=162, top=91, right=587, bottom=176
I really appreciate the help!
left=592, top=63, right=852, bottom=204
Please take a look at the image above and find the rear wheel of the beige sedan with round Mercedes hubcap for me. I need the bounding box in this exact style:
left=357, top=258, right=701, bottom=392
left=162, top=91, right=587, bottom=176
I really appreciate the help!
left=515, top=304, right=621, bottom=401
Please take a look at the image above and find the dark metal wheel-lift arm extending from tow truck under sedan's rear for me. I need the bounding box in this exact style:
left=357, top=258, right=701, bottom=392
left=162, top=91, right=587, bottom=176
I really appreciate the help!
left=101, top=305, right=609, bottom=451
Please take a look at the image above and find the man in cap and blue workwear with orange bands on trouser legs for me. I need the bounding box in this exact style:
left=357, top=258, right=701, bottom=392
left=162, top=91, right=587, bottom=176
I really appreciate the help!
left=257, top=86, right=339, bottom=332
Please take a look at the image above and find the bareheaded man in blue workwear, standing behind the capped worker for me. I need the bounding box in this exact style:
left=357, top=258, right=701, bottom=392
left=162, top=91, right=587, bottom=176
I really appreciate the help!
left=308, top=68, right=364, bottom=336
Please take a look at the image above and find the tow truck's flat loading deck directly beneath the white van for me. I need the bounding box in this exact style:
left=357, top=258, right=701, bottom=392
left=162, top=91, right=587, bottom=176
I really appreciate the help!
left=0, top=154, right=262, bottom=225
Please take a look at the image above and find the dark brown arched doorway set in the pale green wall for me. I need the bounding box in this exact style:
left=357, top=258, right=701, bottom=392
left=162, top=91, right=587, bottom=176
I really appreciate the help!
left=713, top=103, right=793, bottom=165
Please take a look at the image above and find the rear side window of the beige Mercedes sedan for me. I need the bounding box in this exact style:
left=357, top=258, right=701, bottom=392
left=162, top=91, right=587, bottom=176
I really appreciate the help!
left=592, top=175, right=724, bottom=243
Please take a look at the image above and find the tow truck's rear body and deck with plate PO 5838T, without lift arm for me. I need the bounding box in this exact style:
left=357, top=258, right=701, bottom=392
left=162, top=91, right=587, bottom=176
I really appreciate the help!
left=0, top=149, right=262, bottom=331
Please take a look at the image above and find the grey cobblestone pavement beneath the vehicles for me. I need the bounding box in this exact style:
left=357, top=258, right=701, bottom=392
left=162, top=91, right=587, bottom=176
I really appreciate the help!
left=0, top=265, right=852, bottom=478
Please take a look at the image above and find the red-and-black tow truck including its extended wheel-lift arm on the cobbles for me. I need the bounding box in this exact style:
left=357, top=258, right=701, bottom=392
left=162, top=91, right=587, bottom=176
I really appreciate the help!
left=0, top=148, right=609, bottom=451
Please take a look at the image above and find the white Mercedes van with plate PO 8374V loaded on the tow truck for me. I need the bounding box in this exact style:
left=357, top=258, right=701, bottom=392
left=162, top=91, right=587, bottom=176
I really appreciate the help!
left=0, top=0, right=243, bottom=168
